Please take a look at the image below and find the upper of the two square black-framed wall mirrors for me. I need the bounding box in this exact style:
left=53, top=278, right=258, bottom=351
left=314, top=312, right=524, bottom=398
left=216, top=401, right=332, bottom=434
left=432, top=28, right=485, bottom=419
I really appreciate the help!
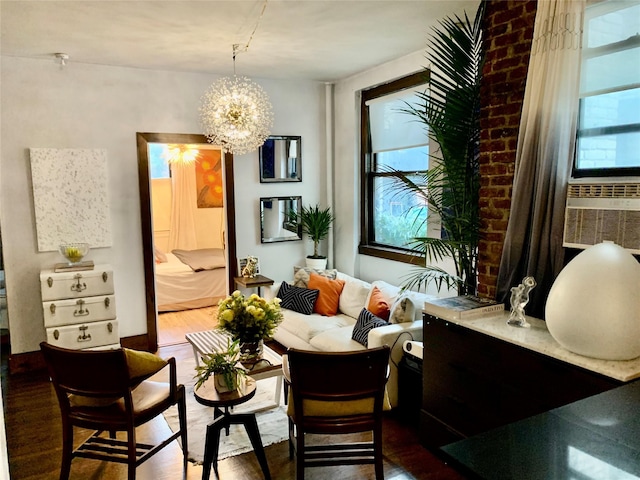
left=259, top=136, right=302, bottom=183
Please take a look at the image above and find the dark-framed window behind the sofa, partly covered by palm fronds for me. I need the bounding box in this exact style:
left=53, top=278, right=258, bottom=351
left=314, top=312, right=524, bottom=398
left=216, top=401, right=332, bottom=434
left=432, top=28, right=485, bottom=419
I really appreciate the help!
left=360, top=72, right=429, bottom=262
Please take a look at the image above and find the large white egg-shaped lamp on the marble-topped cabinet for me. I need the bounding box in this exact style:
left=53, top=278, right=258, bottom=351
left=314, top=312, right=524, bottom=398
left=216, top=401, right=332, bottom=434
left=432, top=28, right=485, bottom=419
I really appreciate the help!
left=545, top=242, right=640, bottom=360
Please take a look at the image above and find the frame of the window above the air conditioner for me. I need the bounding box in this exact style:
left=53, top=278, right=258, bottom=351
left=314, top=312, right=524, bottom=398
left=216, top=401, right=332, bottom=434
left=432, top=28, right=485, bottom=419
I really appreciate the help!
left=571, top=2, right=640, bottom=178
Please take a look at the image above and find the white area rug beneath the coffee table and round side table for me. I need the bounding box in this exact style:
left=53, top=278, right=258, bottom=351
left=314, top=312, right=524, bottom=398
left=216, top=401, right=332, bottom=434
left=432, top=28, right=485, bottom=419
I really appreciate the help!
left=164, top=357, right=289, bottom=464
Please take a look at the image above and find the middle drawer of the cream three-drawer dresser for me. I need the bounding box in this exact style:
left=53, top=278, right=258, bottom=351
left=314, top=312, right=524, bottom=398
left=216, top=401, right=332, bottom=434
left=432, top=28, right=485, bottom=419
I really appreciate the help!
left=42, top=295, right=116, bottom=327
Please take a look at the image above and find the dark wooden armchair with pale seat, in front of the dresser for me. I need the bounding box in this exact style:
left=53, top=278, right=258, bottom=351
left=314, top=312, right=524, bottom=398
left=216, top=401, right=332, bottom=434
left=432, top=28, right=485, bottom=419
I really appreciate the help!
left=40, top=342, right=188, bottom=480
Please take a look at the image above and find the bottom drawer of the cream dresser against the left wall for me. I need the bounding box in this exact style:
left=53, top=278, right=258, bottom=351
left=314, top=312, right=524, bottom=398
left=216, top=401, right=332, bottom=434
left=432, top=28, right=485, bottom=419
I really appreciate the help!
left=47, top=320, right=120, bottom=349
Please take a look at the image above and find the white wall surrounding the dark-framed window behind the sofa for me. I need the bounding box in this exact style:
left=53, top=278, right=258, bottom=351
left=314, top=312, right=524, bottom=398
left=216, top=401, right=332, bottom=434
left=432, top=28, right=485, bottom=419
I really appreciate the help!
left=334, top=51, right=450, bottom=296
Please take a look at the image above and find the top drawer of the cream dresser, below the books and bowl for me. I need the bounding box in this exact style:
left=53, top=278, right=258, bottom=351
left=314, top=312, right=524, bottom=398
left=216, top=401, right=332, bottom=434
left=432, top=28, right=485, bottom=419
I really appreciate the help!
left=40, top=265, right=114, bottom=302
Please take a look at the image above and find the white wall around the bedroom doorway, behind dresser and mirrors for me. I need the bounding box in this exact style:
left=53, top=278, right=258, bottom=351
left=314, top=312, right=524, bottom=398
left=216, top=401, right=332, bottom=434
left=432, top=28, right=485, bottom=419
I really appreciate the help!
left=0, top=56, right=326, bottom=353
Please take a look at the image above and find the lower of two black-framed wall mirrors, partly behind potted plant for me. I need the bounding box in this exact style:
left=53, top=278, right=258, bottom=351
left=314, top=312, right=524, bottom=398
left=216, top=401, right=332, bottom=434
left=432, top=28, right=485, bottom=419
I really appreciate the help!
left=260, top=197, right=302, bottom=243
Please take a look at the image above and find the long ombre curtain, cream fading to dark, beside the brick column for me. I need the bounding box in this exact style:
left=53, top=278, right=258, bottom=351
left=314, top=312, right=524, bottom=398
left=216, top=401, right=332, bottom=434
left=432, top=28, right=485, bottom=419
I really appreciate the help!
left=497, top=0, right=585, bottom=318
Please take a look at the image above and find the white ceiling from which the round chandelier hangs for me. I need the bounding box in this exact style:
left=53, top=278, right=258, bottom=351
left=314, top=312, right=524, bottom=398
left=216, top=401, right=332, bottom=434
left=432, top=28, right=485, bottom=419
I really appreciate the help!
left=0, top=0, right=479, bottom=82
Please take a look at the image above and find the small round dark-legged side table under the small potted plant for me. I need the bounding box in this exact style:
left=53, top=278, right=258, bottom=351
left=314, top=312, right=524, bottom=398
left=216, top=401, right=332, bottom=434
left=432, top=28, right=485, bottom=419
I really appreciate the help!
left=193, top=377, right=271, bottom=480
